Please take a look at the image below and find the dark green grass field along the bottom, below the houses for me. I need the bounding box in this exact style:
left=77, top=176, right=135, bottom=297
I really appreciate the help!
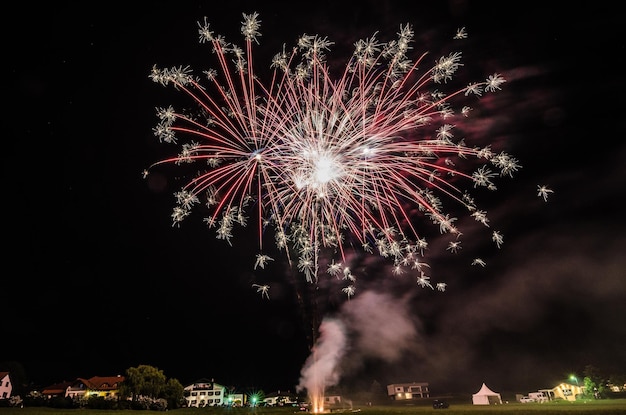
left=0, top=399, right=626, bottom=415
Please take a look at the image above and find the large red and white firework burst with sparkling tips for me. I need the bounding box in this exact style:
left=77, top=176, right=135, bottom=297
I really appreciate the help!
left=145, top=13, right=520, bottom=298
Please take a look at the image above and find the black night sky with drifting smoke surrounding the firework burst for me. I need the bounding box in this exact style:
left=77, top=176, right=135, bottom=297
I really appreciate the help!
left=0, top=0, right=626, bottom=393
